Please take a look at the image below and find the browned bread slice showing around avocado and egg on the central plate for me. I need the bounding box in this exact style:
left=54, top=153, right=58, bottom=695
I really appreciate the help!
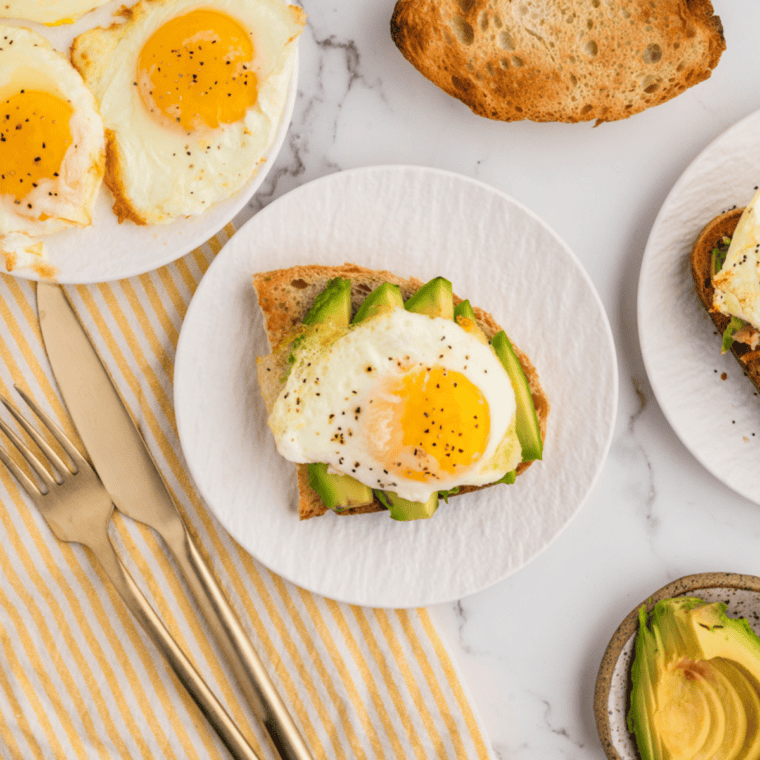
left=254, top=264, right=549, bottom=519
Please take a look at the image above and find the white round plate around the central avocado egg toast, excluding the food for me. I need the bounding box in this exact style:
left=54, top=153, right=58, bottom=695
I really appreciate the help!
left=175, top=166, right=617, bottom=607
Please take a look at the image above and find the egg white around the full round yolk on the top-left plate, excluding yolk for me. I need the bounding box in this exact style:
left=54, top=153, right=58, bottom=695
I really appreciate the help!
left=72, top=0, right=305, bottom=224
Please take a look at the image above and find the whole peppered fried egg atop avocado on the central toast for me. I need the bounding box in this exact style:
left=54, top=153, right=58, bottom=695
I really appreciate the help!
left=269, top=308, right=522, bottom=501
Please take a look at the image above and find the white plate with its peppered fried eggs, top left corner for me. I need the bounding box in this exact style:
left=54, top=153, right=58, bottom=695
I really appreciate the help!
left=0, top=0, right=305, bottom=283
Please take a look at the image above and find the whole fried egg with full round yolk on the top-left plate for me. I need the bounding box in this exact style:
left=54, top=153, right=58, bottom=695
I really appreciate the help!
left=72, top=0, right=305, bottom=224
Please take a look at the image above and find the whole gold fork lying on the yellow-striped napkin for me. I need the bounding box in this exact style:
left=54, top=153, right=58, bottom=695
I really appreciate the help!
left=0, top=386, right=260, bottom=760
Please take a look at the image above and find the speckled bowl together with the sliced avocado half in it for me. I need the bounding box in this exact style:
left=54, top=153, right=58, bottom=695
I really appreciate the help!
left=594, top=573, right=760, bottom=760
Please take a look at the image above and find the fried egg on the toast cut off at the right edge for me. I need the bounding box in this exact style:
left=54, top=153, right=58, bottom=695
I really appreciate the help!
left=712, top=191, right=760, bottom=330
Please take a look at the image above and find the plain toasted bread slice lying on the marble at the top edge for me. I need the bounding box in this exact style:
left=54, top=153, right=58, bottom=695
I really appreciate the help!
left=391, top=0, right=726, bottom=123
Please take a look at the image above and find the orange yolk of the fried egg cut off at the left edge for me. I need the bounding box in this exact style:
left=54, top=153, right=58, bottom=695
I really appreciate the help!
left=0, top=90, right=74, bottom=203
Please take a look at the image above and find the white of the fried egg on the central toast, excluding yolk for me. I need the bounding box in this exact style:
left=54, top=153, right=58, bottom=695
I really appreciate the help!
left=269, top=309, right=521, bottom=501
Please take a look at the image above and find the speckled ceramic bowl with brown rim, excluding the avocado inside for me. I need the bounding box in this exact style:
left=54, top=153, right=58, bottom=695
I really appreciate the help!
left=594, top=573, right=760, bottom=760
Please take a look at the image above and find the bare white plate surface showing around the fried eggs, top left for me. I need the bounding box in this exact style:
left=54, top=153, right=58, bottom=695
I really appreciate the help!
left=0, top=0, right=298, bottom=284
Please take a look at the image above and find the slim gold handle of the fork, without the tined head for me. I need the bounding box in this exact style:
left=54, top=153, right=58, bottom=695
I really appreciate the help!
left=88, top=536, right=261, bottom=760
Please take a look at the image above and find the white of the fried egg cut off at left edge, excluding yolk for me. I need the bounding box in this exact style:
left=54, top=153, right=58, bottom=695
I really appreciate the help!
left=0, top=26, right=105, bottom=271
